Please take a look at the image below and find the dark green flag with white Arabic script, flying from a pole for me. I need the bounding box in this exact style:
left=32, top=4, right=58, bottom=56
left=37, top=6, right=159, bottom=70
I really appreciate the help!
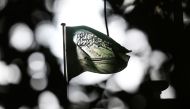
left=64, top=26, right=130, bottom=80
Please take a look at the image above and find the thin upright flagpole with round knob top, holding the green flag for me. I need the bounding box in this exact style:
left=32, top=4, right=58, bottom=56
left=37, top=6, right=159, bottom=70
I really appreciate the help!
left=61, top=23, right=69, bottom=108
